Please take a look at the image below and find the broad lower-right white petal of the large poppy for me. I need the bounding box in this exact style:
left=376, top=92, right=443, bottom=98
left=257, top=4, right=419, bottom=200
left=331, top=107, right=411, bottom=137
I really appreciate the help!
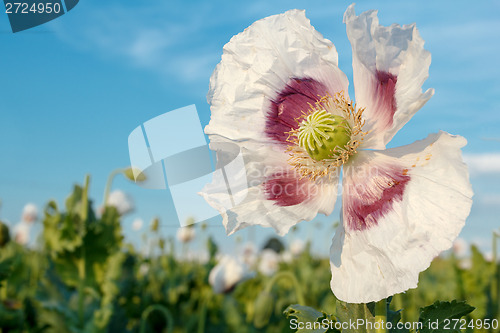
left=330, top=132, right=473, bottom=303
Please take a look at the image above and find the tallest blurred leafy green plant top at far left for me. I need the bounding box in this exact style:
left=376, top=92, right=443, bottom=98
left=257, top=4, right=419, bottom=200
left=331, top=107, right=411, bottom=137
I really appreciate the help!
left=43, top=178, right=123, bottom=288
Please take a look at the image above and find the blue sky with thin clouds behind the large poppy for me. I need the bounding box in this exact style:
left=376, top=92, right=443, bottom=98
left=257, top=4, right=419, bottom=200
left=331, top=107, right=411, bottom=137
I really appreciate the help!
left=0, top=0, right=500, bottom=255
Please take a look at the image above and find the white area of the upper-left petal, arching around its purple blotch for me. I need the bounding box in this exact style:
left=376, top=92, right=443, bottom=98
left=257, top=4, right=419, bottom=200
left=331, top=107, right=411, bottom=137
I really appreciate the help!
left=205, top=10, right=348, bottom=146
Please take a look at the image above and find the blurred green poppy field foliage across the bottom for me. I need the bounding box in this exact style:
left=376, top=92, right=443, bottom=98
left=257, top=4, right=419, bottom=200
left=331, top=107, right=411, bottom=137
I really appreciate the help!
left=0, top=177, right=500, bottom=333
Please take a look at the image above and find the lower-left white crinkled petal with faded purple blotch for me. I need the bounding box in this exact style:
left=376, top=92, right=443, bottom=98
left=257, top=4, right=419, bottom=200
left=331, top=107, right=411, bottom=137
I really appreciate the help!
left=200, top=146, right=338, bottom=235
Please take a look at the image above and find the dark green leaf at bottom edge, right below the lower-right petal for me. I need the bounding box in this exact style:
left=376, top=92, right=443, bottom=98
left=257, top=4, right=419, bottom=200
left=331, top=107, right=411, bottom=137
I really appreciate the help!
left=419, top=300, right=475, bottom=333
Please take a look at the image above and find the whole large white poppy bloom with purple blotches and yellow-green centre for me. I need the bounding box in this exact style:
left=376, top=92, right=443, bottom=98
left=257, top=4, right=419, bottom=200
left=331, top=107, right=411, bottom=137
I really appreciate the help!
left=201, top=5, right=473, bottom=303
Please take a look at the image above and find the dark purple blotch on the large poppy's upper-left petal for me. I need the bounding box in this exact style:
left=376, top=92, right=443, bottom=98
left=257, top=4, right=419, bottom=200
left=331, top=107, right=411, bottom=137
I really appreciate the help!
left=265, top=78, right=328, bottom=144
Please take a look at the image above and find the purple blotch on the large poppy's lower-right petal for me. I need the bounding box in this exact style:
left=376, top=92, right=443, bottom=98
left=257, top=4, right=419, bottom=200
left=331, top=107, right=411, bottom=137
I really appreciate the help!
left=344, top=167, right=410, bottom=231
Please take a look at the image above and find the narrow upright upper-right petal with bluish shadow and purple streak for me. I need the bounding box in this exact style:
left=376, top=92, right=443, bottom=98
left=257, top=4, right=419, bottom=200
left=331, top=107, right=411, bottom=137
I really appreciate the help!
left=344, top=5, right=434, bottom=149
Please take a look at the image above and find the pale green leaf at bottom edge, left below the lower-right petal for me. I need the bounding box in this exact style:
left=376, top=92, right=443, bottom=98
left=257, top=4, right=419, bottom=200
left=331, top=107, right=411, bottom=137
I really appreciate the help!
left=283, top=304, right=340, bottom=333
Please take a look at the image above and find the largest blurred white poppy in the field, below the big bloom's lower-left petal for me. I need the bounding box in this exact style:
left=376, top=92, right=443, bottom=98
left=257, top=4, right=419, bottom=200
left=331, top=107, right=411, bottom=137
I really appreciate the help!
left=208, top=255, right=251, bottom=294
